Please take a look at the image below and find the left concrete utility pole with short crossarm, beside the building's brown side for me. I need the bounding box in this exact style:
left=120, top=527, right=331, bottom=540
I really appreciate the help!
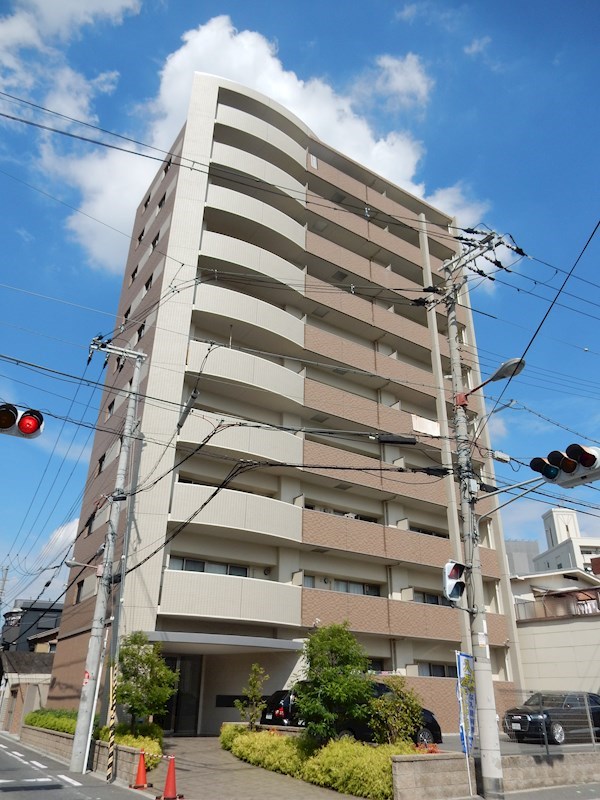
left=70, top=339, right=146, bottom=774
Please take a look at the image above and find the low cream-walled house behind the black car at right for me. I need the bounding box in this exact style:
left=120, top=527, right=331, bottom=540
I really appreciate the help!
left=511, top=569, right=600, bottom=692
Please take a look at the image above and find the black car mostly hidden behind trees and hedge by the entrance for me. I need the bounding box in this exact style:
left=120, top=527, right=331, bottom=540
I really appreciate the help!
left=260, top=681, right=442, bottom=744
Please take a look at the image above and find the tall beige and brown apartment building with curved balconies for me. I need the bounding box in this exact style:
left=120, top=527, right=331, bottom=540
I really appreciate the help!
left=50, top=74, right=520, bottom=735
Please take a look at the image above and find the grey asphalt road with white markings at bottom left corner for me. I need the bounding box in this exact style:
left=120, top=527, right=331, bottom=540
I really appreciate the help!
left=0, top=739, right=133, bottom=800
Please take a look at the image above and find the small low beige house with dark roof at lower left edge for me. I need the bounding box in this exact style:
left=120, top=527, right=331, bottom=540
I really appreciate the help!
left=0, top=651, right=54, bottom=733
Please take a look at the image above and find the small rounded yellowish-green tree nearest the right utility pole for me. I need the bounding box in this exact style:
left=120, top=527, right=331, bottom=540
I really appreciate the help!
left=369, top=675, right=423, bottom=744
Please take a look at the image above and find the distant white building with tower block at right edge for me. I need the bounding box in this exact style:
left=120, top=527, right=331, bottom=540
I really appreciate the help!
left=533, top=508, right=600, bottom=572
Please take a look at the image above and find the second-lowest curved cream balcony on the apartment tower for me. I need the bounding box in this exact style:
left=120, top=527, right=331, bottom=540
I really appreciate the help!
left=169, top=483, right=302, bottom=544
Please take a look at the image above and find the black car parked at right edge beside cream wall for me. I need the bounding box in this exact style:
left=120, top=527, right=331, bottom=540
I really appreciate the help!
left=504, top=692, right=600, bottom=744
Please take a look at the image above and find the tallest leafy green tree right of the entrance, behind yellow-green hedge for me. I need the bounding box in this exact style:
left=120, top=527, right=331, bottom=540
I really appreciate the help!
left=297, top=622, right=372, bottom=746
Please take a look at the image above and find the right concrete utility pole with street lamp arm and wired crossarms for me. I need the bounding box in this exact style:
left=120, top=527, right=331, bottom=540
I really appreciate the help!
left=444, top=238, right=524, bottom=798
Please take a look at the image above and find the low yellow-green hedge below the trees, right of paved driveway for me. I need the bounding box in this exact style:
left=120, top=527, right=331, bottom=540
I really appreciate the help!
left=221, top=725, right=424, bottom=800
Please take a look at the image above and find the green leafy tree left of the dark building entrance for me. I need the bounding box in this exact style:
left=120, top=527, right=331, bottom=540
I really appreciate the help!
left=116, top=631, right=179, bottom=733
